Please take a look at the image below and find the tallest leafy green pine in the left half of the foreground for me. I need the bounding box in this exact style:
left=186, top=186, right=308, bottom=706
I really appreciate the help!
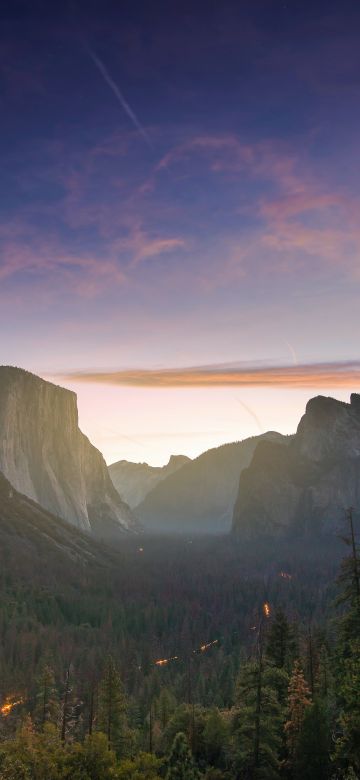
left=97, top=656, right=127, bottom=755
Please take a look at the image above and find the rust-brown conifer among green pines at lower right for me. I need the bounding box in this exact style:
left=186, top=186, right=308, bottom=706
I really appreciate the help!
left=285, top=660, right=311, bottom=766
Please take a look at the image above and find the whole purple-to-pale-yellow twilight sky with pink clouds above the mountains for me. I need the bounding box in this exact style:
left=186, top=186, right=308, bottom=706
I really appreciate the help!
left=0, top=0, right=360, bottom=465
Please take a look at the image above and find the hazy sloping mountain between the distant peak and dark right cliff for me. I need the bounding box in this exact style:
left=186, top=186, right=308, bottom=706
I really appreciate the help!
left=134, top=433, right=283, bottom=533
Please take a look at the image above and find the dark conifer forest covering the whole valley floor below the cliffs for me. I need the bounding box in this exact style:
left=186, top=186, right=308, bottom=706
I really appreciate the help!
left=0, top=514, right=360, bottom=780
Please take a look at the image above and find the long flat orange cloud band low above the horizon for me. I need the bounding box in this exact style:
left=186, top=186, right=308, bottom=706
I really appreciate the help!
left=59, top=361, right=360, bottom=389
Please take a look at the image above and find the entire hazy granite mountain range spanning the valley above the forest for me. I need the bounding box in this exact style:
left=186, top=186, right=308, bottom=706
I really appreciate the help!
left=0, top=366, right=360, bottom=540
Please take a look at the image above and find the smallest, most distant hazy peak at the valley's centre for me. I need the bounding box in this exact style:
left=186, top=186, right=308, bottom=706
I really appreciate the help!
left=109, top=455, right=190, bottom=508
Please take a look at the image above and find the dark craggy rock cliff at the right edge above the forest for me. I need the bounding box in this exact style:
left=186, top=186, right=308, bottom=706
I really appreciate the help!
left=233, top=394, right=360, bottom=537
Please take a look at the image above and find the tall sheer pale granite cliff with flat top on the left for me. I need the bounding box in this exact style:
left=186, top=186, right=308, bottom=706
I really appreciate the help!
left=0, top=366, right=135, bottom=538
